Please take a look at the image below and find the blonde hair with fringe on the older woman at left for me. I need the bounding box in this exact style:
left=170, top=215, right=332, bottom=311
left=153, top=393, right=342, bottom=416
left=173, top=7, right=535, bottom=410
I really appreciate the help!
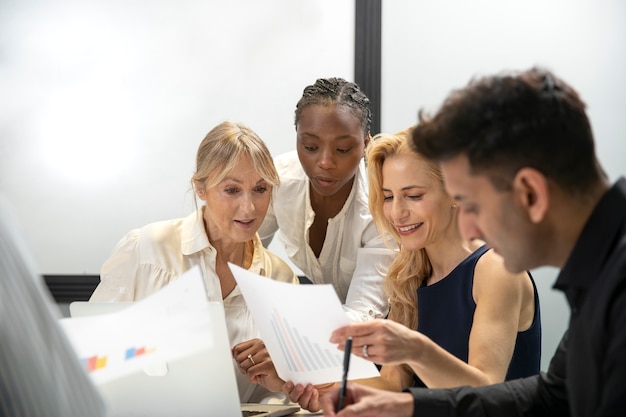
left=191, top=122, right=280, bottom=190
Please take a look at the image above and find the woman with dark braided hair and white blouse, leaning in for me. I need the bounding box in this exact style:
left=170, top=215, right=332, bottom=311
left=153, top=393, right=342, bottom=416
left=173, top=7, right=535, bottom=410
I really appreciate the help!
left=259, top=78, right=395, bottom=322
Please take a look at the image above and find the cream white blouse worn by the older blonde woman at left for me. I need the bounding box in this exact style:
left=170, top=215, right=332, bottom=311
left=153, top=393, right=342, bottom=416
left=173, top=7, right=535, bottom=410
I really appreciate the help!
left=90, top=206, right=298, bottom=402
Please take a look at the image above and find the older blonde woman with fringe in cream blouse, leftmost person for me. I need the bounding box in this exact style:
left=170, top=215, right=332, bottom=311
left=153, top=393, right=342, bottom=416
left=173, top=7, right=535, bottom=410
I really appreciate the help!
left=90, top=122, right=298, bottom=402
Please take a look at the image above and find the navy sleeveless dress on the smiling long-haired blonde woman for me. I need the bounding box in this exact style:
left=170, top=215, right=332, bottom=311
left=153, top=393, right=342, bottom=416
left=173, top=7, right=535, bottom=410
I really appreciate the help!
left=414, top=246, right=541, bottom=387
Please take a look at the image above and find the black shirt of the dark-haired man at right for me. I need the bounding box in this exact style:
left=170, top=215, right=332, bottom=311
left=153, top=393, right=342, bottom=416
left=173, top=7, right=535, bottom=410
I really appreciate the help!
left=409, top=178, right=626, bottom=417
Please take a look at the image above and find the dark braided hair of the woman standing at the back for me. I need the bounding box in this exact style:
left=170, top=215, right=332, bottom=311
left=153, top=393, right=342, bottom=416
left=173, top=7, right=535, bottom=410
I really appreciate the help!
left=295, top=77, right=372, bottom=135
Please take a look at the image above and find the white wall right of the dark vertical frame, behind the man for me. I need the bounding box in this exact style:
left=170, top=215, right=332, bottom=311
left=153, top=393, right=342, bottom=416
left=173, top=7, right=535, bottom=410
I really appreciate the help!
left=381, top=0, right=626, bottom=369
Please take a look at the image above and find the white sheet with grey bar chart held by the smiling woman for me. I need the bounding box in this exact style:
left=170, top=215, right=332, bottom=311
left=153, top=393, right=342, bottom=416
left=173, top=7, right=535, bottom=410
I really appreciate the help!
left=229, top=264, right=380, bottom=384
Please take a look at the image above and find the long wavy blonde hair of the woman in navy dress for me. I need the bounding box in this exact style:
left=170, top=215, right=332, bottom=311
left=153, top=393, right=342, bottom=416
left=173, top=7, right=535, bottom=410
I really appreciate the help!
left=366, top=128, right=443, bottom=329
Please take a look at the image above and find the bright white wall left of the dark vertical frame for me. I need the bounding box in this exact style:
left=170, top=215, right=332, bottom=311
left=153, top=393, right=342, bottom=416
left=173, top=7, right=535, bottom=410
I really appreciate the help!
left=0, top=0, right=354, bottom=274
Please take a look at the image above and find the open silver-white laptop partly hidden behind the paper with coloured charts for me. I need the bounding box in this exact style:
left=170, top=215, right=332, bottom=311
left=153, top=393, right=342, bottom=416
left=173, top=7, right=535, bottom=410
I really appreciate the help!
left=63, top=301, right=300, bottom=417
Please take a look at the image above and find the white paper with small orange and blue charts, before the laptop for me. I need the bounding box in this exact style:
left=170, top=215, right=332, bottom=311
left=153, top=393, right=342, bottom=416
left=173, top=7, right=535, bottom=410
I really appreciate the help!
left=60, top=267, right=215, bottom=383
